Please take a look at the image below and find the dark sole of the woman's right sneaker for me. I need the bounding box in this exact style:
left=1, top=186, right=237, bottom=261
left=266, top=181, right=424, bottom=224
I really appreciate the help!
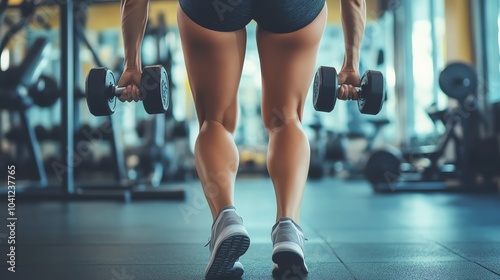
left=272, top=251, right=308, bottom=279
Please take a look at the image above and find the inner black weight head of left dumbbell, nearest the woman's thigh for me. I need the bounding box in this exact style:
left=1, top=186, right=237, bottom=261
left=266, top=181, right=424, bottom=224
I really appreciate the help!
left=141, top=65, right=170, bottom=114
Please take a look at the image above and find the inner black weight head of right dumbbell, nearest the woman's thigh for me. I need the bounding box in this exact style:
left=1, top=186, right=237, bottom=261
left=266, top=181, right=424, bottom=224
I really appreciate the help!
left=313, top=66, right=338, bottom=112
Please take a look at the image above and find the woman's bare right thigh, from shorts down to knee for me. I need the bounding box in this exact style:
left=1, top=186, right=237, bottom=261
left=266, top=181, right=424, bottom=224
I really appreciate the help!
left=257, top=5, right=327, bottom=131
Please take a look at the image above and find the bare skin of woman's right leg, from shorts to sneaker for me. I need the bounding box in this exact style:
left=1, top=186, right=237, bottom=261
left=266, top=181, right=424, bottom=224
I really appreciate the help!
left=257, top=5, right=327, bottom=223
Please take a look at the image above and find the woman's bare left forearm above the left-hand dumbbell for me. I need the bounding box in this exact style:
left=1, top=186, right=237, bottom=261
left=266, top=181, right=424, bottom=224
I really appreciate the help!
left=120, top=0, right=149, bottom=70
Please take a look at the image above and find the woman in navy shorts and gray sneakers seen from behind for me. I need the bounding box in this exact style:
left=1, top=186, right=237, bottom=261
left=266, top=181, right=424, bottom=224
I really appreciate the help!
left=118, top=0, right=366, bottom=278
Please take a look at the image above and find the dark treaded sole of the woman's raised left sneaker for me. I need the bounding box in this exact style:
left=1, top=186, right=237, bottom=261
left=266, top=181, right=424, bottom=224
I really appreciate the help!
left=205, top=235, right=250, bottom=279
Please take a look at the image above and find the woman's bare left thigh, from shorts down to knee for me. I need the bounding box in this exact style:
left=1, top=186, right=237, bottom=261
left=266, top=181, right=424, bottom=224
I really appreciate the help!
left=177, top=6, right=246, bottom=133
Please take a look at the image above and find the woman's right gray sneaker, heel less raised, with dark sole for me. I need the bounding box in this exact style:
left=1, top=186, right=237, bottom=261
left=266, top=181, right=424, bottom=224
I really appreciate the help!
left=271, top=218, right=309, bottom=279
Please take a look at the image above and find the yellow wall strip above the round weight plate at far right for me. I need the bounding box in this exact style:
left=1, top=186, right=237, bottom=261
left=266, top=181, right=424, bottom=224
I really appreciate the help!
left=445, top=0, right=473, bottom=63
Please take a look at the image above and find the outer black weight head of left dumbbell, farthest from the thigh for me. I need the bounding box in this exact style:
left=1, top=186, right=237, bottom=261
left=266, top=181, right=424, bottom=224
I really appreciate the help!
left=85, top=67, right=116, bottom=116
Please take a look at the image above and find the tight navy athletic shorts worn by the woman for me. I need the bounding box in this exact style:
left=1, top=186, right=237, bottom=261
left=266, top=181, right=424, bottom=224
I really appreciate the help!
left=179, top=0, right=325, bottom=33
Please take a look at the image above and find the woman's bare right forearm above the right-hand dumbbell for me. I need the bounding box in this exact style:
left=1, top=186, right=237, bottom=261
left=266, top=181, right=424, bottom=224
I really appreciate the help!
left=341, top=0, right=366, bottom=70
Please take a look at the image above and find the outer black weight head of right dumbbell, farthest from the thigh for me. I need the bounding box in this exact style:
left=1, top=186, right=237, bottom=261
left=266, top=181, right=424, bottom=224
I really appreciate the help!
left=358, top=70, right=385, bottom=115
